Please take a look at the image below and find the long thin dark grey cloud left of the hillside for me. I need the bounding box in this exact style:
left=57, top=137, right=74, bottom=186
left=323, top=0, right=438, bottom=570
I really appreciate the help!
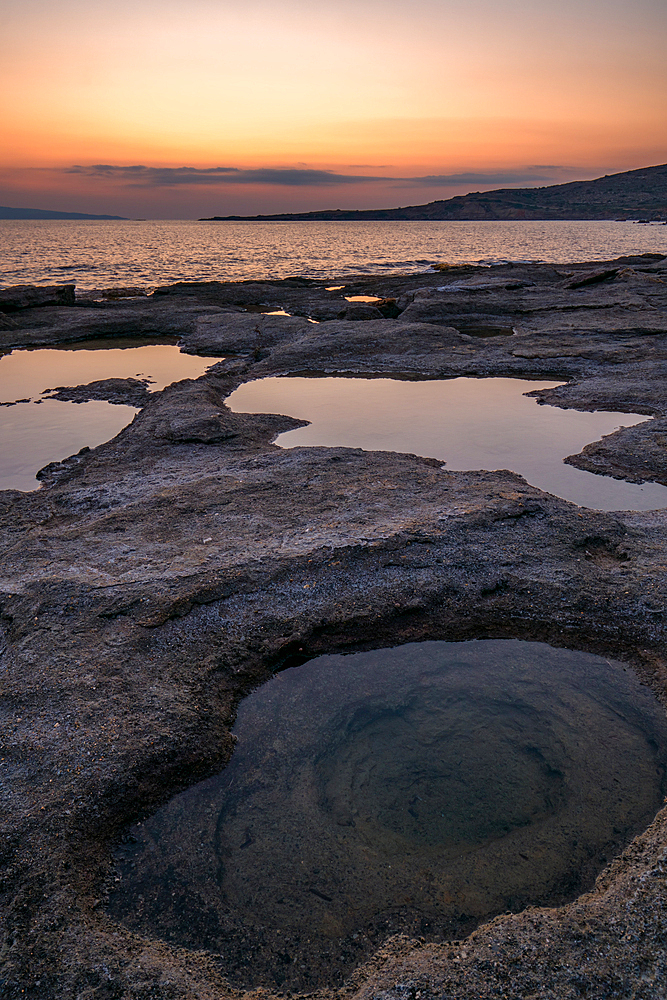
left=65, top=163, right=390, bottom=187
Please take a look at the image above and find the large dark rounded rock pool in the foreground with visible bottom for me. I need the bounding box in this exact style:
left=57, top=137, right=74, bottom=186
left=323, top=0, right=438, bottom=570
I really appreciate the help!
left=110, top=640, right=667, bottom=989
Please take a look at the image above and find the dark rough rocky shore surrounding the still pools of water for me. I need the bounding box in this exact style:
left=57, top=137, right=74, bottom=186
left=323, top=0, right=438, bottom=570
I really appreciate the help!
left=0, top=255, right=667, bottom=1000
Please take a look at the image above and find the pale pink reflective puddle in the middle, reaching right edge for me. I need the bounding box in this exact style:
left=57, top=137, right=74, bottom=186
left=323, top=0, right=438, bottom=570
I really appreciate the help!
left=227, top=377, right=667, bottom=510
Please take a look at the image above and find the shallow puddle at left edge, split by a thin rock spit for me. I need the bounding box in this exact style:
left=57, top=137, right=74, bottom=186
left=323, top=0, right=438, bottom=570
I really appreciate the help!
left=0, top=338, right=220, bottom=491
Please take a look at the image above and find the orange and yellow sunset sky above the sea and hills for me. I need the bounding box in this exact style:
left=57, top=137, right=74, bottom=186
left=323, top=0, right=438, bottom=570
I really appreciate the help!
left=0, top=0, right=667, bottom=219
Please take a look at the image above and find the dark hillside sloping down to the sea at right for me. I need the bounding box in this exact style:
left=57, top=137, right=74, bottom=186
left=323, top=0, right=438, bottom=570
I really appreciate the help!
left=200, top=164, right=667, bottom=222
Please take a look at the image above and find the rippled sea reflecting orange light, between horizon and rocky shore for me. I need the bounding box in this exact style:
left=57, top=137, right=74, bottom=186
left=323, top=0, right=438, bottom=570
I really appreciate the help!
left=0, top=220, right=667, bottom=290
